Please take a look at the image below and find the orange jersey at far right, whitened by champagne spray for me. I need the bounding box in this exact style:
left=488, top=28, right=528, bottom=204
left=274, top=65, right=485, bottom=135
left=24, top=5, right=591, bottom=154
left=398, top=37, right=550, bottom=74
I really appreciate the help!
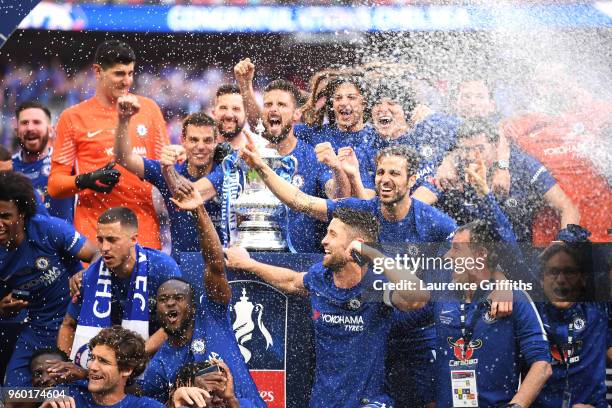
left=502, top=102, right=612, bottom=246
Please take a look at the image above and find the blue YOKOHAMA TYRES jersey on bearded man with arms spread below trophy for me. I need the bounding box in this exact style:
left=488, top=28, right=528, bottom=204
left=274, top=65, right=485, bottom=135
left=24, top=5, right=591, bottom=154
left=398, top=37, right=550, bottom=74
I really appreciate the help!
left=304, top=263, right=393, bottom=408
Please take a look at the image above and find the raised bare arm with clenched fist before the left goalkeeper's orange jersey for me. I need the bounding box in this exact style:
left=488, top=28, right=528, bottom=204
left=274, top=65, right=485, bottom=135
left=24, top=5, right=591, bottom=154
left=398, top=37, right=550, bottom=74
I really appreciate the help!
left=115, top=95, right=144, bottom=178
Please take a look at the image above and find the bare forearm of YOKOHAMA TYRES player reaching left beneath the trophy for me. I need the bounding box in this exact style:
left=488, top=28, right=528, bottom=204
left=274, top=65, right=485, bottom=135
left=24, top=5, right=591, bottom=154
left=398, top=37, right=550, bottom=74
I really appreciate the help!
left=224, top=247, right=308, bottom=295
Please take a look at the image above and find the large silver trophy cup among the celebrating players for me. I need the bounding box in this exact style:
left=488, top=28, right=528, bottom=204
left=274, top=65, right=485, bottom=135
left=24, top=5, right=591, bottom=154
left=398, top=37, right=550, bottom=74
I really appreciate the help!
left=234, top=119, right=287, bottom=252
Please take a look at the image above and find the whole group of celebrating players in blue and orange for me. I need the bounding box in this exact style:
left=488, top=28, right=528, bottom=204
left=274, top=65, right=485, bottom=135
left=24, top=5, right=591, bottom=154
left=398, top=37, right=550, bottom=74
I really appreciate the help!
left=0, top=37, right=612, bottom=408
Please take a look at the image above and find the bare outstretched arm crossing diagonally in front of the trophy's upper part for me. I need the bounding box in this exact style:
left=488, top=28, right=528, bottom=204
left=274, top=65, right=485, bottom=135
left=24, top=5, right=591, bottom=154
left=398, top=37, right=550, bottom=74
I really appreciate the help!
left=240, top=134, right=327, bottom=221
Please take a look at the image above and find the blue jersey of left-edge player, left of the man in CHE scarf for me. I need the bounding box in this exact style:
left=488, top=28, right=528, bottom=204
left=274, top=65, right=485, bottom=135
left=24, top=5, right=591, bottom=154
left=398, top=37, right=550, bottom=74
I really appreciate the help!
left=0, top=214, right=86, bottom=387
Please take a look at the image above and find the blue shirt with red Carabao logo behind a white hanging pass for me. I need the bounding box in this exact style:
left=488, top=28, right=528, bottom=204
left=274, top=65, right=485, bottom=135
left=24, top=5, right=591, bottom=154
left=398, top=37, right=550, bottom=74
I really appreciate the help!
left=416, top=290, right=550, bottom=407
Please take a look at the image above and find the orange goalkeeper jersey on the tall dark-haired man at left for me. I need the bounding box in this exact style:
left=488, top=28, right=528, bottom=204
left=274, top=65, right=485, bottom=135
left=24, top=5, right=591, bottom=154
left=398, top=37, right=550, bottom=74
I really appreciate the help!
left=49, top=96, right=168, bottom=249
